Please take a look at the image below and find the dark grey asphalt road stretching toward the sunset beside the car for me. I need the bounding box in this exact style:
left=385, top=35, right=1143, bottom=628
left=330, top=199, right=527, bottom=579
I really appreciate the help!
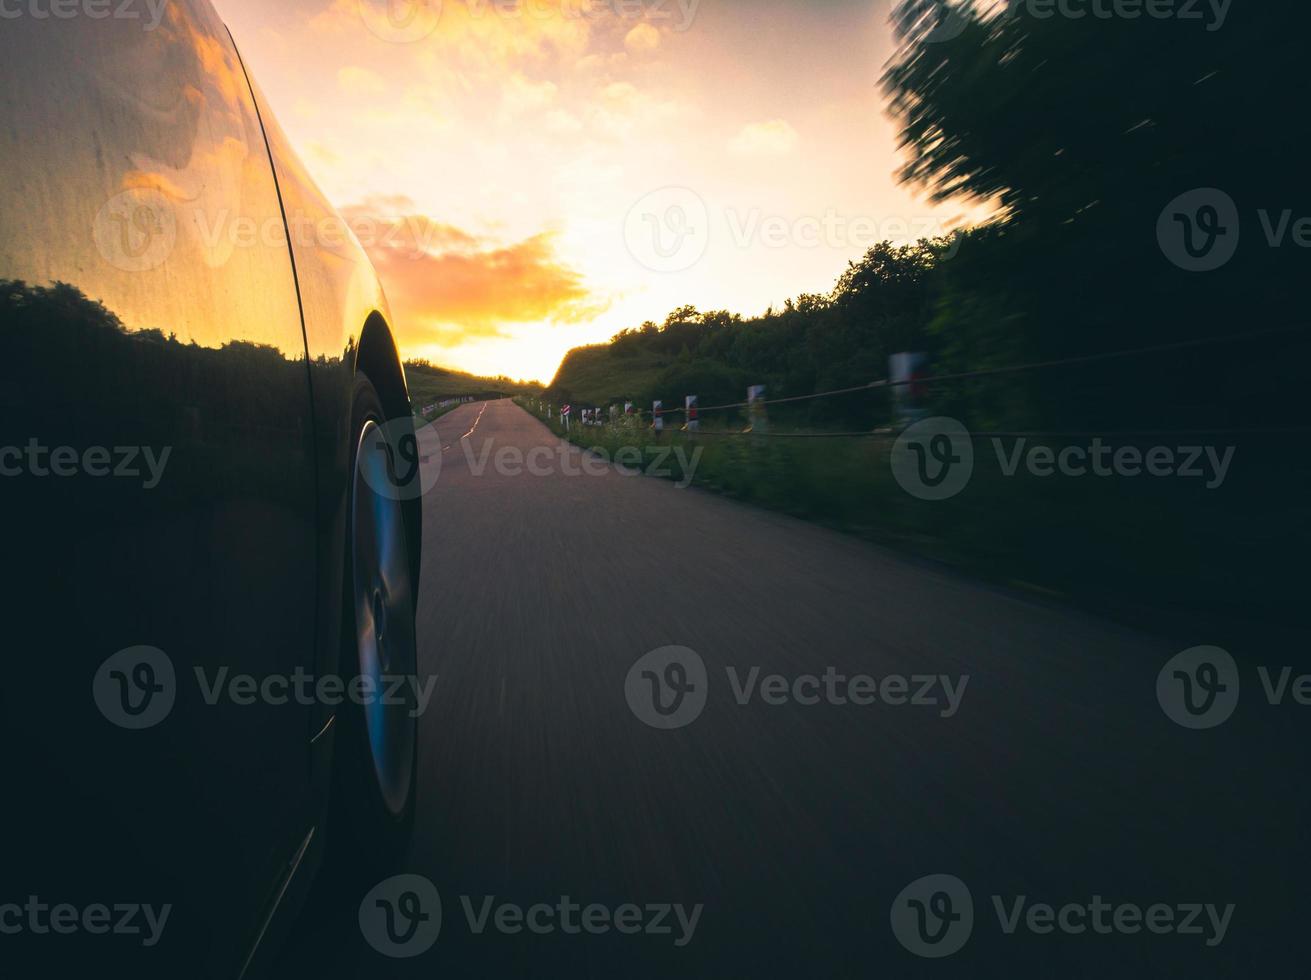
left=286, top=402, right=1311, bottom=977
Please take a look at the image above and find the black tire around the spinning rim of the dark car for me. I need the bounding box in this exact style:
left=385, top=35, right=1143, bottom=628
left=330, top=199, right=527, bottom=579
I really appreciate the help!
left=325, top=375, right=418, bottom=884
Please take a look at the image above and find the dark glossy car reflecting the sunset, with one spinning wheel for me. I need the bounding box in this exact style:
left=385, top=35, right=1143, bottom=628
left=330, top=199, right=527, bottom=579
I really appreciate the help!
left=0, top=0, right=422, bottom=977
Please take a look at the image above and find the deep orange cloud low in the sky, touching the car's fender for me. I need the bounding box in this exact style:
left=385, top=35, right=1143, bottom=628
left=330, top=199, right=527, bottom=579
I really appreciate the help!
left=342, top=195, right=610, bottom=347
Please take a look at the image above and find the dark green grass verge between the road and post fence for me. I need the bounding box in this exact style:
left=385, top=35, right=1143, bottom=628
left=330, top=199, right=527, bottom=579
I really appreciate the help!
left=520, top=401, right=1311, bottom=643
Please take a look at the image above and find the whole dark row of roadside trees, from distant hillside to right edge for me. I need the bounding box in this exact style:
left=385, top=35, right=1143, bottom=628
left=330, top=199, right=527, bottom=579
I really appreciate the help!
left=552, top=0, right=1311, bottom=430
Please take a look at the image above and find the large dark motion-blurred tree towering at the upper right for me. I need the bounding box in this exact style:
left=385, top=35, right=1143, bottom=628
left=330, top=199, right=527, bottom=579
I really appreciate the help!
left=884, top=0, right=1311, bottom=423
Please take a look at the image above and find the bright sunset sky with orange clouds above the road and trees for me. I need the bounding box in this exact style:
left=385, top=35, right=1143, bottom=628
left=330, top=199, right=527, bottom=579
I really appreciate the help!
left=215, top=0, right=969, bottom=381
